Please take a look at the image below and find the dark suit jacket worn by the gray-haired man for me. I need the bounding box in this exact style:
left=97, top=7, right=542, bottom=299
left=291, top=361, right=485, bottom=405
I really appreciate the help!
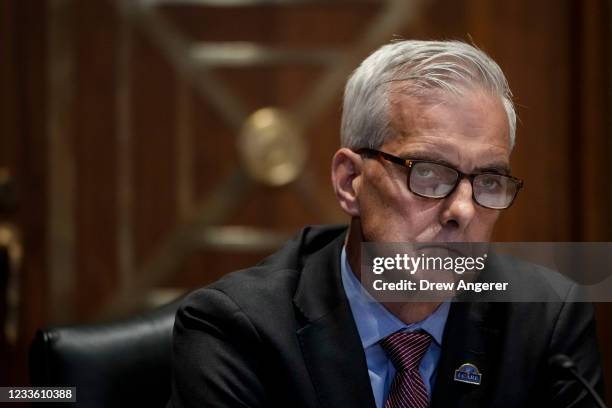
left=169, top=227, right=603, bottom=408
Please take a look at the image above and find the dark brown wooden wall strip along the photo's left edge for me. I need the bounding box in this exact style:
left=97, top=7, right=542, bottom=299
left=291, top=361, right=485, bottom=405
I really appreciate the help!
left=0, top=0, right=49, bottom=384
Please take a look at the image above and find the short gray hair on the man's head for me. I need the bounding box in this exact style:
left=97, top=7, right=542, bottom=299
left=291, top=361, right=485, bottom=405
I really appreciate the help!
left=341, top=40, right=516, bottom=149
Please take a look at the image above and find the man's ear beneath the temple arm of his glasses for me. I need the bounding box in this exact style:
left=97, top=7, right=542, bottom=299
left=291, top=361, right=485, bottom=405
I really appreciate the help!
left=331, top=147, right=363, bottom=217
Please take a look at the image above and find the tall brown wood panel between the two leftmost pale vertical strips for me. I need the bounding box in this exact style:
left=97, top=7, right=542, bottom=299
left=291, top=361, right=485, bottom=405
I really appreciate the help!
left=72, top=2, right=118, bottom=319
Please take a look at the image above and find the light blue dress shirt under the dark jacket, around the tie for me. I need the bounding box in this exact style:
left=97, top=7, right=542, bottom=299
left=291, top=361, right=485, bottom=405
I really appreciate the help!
left=340, top=248, right=450, bottom=408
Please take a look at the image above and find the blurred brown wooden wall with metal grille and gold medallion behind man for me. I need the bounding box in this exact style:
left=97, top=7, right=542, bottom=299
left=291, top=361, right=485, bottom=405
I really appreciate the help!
left=0, top=0, right=612, bottom=399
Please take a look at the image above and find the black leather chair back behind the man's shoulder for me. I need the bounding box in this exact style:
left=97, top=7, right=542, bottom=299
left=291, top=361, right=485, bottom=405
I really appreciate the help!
left=29, top=299, right=181, bottom=407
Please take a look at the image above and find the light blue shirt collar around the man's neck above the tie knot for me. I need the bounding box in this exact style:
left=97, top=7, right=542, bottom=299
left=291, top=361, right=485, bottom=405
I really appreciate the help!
left=340, top=247, right=450, bottom=349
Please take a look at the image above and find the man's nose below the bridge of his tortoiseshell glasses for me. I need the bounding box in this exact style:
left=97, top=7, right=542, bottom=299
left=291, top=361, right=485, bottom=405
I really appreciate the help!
left=440, top=178, right=476, bottom=232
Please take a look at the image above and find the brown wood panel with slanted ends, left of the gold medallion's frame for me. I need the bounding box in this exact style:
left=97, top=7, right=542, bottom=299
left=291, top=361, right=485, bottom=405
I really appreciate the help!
left=131, top=31, right=177, bottom=273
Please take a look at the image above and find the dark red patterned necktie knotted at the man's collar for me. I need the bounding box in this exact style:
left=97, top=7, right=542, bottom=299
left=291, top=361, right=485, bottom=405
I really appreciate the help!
left=380, top=331, right=431, bottom=408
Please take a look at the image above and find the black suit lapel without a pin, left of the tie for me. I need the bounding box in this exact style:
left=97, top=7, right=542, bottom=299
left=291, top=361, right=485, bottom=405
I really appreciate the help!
left=294, top=234, right=375, bottom=408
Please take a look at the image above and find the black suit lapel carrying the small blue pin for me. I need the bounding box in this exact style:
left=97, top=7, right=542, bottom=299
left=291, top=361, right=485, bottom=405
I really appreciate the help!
left=431, top=302, right=503, bottom=408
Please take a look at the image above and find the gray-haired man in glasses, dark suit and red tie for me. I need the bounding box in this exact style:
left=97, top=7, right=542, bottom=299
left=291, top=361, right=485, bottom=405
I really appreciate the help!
left=169, top=41, right=602, bottom=408
